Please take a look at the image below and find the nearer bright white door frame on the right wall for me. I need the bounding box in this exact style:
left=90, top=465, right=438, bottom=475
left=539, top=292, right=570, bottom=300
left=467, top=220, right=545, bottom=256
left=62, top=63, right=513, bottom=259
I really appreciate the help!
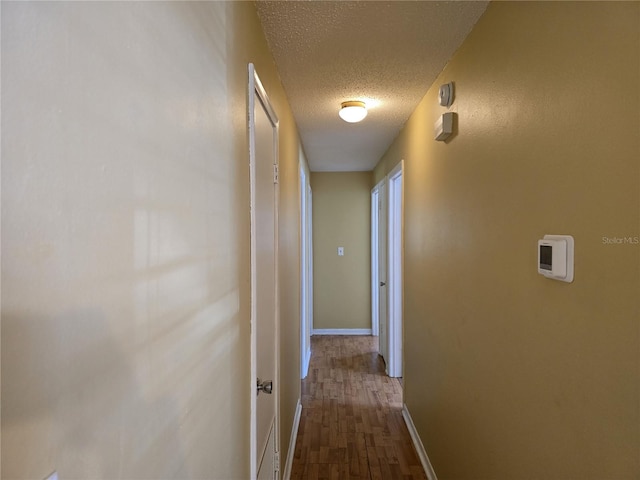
left=387, top=160, right=404, bottom=377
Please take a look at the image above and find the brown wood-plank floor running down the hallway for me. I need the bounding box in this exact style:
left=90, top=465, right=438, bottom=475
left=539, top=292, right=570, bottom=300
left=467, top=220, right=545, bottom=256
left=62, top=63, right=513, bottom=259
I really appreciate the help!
left=291, top=335, right=427, bottom=480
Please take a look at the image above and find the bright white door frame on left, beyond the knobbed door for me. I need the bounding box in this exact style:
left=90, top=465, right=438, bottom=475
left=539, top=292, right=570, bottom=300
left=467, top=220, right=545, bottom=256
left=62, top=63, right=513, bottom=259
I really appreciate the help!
left=300, top=161, right=313, bottom=378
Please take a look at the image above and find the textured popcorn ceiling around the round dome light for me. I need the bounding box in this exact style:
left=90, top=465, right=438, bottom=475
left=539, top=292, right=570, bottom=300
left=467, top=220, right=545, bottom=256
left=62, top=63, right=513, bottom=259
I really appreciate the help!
left=256, top=1, right=488, bottom=171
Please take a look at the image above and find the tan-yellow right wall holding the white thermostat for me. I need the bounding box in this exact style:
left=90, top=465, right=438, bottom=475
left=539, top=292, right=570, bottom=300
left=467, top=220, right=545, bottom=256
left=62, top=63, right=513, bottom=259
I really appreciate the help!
left=374, top=2, right=640, bottom=480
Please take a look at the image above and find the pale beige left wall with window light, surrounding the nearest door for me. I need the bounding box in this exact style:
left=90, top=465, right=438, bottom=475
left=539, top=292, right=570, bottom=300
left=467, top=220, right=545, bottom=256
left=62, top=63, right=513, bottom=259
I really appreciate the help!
left=1, top=2, right=300, bottom=479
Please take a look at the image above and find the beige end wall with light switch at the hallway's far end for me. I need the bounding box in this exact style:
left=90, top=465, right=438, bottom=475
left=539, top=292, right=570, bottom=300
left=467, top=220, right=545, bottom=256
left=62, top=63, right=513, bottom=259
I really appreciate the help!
left=311, top=172, right=371, bottom=329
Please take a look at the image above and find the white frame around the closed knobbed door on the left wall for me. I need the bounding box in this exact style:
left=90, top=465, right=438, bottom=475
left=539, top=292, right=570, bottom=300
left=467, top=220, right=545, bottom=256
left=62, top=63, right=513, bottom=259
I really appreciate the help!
left=248, top=63, right=280, bottom=479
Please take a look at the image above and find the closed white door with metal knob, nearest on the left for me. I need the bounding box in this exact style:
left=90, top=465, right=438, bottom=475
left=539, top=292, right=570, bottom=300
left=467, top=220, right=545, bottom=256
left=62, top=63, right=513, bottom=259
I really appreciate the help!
left=249, top=65, right=278, bottom=480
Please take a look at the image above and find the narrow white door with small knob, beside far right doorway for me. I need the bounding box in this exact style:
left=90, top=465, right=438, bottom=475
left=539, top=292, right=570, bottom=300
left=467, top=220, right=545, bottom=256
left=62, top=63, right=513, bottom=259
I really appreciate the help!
left=378, top=181, right=389, bottom=373
